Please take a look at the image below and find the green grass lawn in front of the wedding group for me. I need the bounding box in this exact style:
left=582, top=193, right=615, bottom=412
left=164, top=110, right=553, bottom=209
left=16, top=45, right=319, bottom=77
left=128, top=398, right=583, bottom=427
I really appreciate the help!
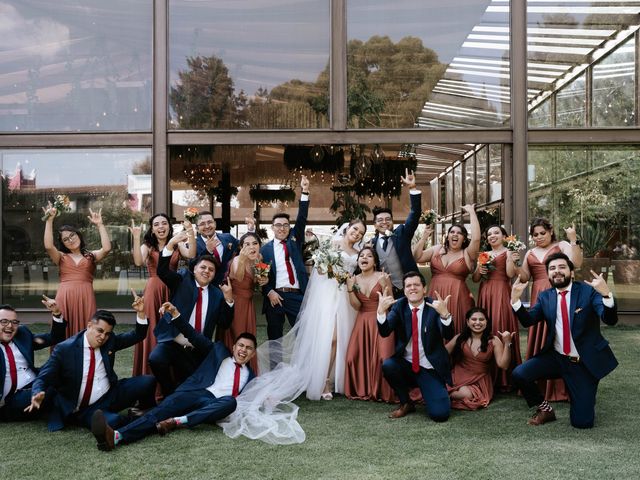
left=0, top=326, right=640, bottom=480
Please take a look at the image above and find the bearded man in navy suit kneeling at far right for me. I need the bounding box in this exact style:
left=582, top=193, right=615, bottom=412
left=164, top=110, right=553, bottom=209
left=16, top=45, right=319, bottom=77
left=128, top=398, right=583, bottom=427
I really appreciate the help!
left=511, top=253, right=618, bottom=428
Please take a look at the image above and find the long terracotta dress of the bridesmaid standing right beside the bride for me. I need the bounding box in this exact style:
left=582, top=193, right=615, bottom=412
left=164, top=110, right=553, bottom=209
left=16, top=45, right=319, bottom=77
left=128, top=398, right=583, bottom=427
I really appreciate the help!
left=344, top=283, right=396, bottom=403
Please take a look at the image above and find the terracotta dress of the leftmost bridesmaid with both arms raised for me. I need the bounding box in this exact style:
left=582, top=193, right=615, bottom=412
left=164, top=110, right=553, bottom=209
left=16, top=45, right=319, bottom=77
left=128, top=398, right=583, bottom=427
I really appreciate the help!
left=56, top=253, right=96, bottom=338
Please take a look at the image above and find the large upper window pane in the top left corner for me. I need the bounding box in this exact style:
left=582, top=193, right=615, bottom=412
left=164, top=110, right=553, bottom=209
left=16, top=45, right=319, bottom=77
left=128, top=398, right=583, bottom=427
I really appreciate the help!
left=0, top=0, right=153, bottom=132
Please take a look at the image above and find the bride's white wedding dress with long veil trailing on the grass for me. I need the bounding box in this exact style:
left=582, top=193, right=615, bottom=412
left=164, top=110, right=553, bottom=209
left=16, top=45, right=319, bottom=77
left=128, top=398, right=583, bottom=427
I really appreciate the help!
left=218, top=252, right=357, bottom=444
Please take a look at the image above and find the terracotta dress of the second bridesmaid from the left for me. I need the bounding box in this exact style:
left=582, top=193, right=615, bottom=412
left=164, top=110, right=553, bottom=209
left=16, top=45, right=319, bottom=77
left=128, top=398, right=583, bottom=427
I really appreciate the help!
left=132, top=249, right=180, bottom=376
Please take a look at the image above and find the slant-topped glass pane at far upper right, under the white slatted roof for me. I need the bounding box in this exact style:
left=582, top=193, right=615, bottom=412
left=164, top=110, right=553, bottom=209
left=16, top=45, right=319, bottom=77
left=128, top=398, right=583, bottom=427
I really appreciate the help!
left=593, top=38, right=636, bottom=127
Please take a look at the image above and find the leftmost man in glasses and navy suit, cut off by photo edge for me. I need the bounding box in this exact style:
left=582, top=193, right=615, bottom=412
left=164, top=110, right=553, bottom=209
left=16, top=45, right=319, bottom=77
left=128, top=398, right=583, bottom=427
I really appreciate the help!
left=0, top=295, right=67, bottom=421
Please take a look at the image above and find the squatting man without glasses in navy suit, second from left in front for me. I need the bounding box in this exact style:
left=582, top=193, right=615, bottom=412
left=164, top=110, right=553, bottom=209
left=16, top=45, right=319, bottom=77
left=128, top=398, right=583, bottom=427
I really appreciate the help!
left=27, top=293, right=156, bottom=431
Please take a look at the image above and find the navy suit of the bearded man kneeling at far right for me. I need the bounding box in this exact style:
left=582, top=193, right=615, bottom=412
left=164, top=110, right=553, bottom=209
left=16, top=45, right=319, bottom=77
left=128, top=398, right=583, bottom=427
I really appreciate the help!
left=513, top=282, right=618, bottom=428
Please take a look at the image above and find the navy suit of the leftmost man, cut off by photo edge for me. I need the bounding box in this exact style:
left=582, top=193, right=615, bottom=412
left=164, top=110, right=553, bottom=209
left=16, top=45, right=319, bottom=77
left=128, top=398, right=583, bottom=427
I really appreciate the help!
left=0, top=321, right=67, bottom=421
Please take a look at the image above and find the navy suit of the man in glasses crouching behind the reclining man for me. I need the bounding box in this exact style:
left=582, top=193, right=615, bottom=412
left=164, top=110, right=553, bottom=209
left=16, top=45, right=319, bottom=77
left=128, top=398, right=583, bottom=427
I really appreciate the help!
left=149, top=255, right=233, bottom=396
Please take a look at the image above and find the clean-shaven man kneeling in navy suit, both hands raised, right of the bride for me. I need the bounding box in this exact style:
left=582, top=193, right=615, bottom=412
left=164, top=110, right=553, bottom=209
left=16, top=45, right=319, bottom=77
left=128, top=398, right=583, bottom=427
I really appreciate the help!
left=377, top=271, right=453, bottom=422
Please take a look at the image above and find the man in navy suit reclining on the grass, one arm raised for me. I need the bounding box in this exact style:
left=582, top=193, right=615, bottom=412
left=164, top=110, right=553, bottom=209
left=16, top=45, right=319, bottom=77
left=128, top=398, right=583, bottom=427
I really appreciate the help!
left=91, top=302, right=256, bottom=451
